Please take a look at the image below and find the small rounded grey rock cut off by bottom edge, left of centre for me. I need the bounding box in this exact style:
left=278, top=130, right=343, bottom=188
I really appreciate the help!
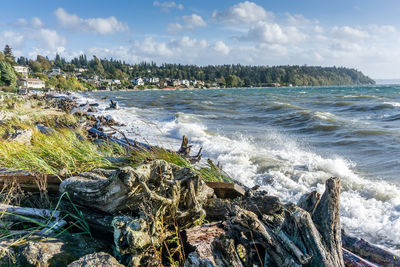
left=68, top=252, right=124, bottom=267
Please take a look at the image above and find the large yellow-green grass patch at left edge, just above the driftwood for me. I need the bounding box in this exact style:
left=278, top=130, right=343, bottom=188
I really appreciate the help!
left=0, top=130, right=111, bottom=174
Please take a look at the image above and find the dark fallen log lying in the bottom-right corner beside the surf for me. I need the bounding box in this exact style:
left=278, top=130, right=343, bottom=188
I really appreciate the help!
left=342, top=231, right=400, bottom=267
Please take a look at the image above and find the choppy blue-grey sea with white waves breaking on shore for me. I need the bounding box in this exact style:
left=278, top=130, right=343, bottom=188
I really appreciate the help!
left=79, top=85, right=400, bottom=252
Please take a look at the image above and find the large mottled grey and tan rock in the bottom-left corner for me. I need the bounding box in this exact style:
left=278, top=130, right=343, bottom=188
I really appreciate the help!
left=5, top=235, right=105, bottom=267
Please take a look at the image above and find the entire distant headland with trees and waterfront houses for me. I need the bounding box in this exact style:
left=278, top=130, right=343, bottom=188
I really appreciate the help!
left=0, top=45, right=375, bottom=91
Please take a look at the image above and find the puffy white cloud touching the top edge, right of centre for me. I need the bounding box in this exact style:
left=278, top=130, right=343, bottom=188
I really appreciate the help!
left=212, top=1, right=274, bottom=24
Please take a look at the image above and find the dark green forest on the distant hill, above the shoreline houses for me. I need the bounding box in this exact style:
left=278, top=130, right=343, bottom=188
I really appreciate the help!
left=17, top=55, right=375, bottom=87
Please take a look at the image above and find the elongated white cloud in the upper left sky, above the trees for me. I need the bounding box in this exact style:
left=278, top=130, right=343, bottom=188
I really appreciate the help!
left=54, top=8, right=128, bottom=34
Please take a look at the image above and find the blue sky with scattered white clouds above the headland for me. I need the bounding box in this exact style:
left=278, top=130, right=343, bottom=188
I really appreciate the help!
left=0, top=0, right=400, bottom=79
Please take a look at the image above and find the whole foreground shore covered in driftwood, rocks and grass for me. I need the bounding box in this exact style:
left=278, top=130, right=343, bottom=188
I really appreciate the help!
left=0, top=94, right=400, bottom=267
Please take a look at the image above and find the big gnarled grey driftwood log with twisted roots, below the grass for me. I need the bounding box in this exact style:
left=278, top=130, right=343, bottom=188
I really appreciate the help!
left=60, top=160, right=213, bottom=229
